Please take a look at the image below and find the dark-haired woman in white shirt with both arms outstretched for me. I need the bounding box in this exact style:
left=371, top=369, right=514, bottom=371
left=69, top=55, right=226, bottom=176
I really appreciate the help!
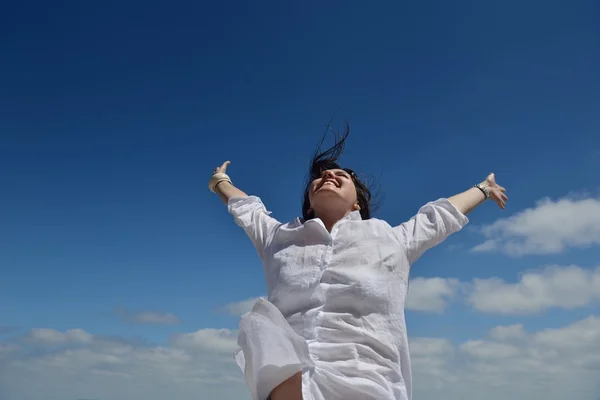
left=209, top=127, right=508, bottom=400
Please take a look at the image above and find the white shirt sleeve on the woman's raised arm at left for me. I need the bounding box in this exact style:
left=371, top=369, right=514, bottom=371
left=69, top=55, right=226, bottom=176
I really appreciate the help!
left=227, top=196, right=281, bottom=259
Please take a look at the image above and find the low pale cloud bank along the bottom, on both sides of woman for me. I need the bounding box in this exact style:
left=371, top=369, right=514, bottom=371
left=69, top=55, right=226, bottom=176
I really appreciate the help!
left=0, top=316, right=600, bottom=400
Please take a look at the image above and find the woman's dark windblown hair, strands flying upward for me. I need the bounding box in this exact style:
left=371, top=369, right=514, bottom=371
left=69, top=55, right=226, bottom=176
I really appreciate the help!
left=302, top=122, right=372, bottom=221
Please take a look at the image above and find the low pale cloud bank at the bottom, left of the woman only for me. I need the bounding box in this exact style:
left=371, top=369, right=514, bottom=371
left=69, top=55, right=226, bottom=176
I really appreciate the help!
left=0, top=329, right=249, bottom=400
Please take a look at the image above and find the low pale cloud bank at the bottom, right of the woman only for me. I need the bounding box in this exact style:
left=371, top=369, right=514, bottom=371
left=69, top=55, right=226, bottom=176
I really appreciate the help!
left=411, top=316, right=600, bottom=400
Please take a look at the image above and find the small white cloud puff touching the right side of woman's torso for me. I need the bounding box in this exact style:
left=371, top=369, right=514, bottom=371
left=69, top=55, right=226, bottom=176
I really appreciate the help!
left=406, top=278, right=460, bottom=312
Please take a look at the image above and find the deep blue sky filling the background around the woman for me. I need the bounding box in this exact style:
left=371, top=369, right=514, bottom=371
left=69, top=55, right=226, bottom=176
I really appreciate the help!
left=0, top=1, right=600, bottom=400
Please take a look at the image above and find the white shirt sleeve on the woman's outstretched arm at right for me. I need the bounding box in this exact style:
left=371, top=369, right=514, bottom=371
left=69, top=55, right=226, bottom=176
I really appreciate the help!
left=393, top=199, right=469, bottom=264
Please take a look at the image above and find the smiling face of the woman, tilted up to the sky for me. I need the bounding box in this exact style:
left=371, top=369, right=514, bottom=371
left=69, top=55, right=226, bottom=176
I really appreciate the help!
left=308, top=169, right=356, bottom=211
